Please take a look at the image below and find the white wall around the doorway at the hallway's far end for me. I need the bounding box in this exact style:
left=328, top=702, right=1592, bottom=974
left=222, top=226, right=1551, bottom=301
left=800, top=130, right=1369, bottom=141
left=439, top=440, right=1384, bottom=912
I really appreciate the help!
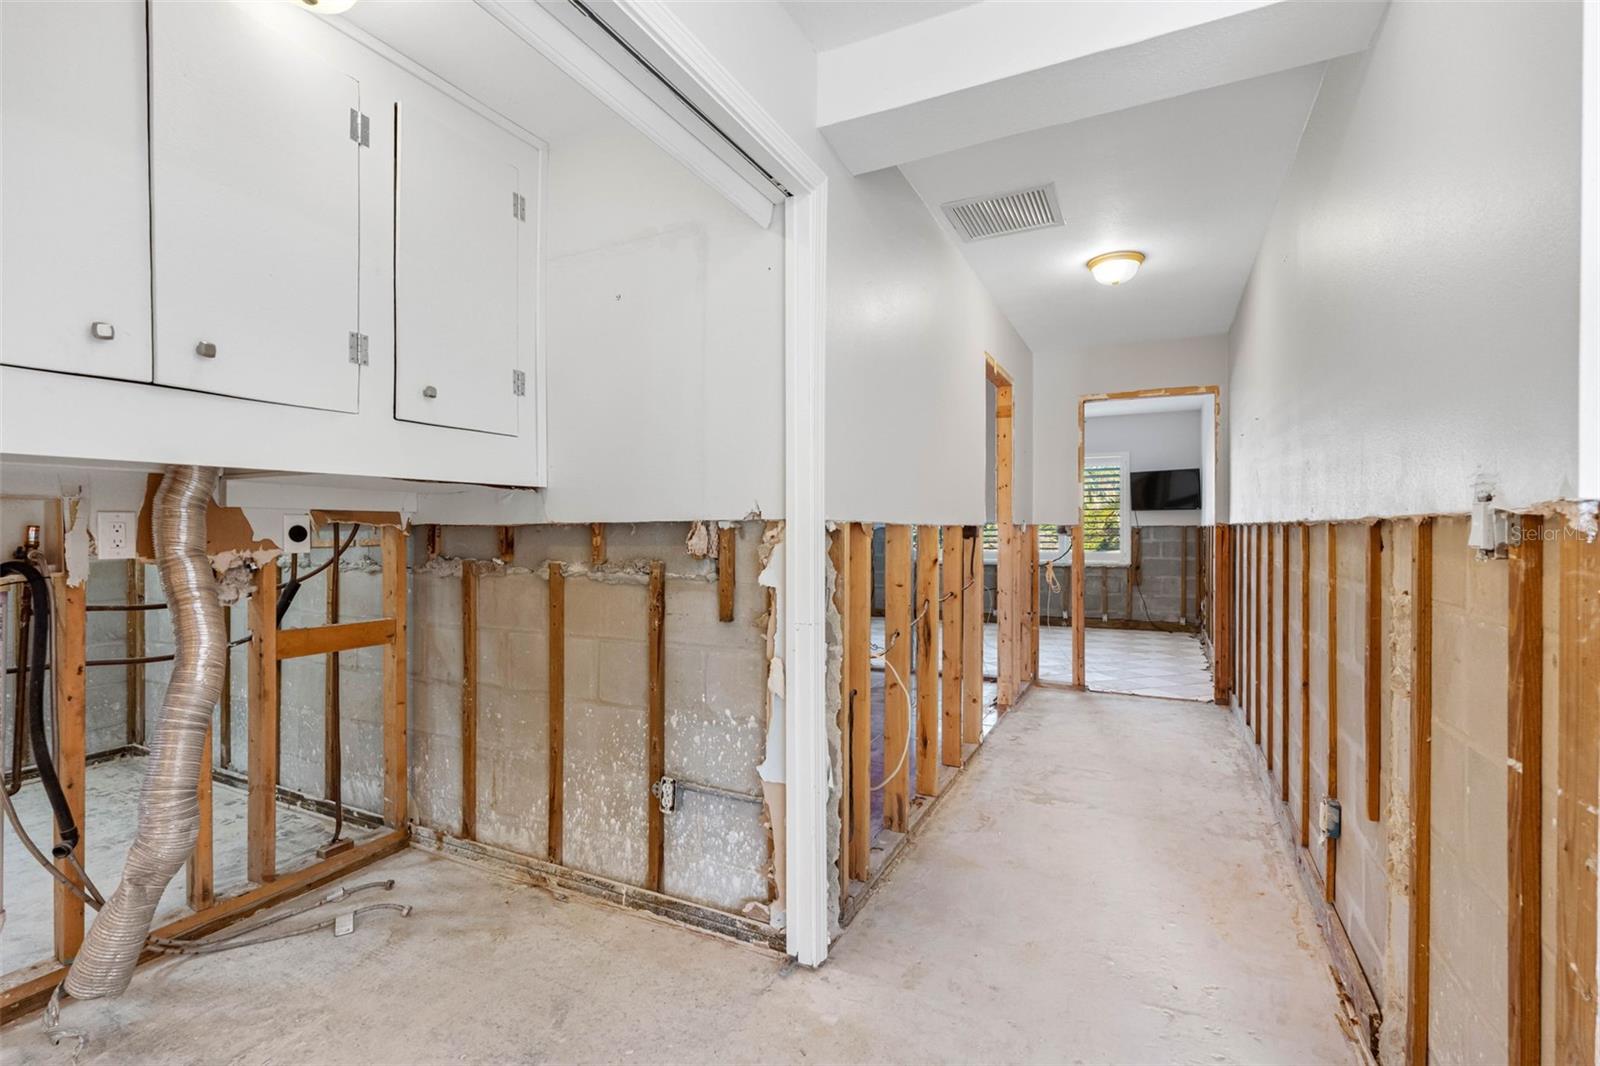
left=1034, top=328, right=1229, bottom=525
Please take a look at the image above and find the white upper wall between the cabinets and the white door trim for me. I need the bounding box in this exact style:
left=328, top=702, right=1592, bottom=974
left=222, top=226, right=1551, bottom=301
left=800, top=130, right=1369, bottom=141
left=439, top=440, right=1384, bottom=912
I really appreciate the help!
left=544, top=118, right=784, bottom=522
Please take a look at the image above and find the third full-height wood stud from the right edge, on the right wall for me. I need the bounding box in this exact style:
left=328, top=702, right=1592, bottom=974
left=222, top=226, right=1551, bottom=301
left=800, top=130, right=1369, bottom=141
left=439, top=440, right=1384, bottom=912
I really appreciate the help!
left=1406, top=519, right=1440, bottom=1066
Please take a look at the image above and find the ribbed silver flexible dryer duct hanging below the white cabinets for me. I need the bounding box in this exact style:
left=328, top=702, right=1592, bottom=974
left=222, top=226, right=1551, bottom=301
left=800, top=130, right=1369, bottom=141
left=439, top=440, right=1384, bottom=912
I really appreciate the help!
left=66, top=466, right=227, bottom=999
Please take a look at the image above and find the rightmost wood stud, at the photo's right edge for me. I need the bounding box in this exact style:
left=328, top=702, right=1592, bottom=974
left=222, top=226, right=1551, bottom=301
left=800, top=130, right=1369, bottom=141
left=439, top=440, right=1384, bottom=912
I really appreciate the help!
left=1554, top=518, right=1600, bottom=1066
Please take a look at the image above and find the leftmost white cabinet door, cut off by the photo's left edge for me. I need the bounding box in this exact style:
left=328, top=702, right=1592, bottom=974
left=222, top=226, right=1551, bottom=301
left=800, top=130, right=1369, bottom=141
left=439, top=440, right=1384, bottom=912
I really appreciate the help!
left=0, top=0, right=150, bottom=381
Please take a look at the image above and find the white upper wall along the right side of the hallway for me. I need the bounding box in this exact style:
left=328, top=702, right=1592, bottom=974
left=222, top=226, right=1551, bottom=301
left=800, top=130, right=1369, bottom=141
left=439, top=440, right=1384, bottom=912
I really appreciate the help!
left=1229, top=3, right=1582, bottom=522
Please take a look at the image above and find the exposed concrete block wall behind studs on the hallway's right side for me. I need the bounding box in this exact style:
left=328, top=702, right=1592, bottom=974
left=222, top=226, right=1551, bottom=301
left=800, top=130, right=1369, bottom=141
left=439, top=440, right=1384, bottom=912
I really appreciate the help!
left=1235, top=517, right=1560, bottom=1063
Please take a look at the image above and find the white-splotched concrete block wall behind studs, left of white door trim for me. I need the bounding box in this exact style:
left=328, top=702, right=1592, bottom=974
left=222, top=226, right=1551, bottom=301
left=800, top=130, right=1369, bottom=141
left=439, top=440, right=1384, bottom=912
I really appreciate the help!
left=411, top=522, right=770, bottom=911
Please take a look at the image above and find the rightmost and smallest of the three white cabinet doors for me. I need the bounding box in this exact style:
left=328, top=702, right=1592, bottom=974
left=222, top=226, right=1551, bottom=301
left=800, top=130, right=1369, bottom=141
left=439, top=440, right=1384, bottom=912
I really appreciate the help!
left=395, top=91, right=538, bottom=434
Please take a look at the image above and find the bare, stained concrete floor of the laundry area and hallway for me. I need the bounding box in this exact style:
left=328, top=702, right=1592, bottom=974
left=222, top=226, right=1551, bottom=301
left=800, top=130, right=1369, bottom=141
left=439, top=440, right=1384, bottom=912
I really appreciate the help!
left=0, top=690, right=1360, bottom=1064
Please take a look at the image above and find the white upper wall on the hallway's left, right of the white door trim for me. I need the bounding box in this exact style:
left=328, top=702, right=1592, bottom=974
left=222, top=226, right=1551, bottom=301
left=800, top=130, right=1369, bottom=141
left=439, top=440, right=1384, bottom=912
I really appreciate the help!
left=652, top=0, right=1034, bottom=523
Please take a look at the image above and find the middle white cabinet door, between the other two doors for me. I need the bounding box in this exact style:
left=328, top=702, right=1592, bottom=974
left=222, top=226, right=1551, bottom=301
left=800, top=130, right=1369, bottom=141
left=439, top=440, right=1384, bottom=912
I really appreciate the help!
left=150, top=0, right=363, bottom=411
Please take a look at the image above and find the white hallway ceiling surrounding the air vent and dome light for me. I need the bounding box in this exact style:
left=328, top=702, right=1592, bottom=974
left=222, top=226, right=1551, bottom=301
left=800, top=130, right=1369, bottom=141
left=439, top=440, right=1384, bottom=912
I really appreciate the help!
left=901, top=64, right=1322, bottom=348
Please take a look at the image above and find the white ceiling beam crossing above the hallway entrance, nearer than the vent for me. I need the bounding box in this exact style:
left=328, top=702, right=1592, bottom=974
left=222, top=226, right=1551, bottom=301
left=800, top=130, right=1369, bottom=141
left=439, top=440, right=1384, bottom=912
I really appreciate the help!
left=818, top=0, right=1386, bottom=174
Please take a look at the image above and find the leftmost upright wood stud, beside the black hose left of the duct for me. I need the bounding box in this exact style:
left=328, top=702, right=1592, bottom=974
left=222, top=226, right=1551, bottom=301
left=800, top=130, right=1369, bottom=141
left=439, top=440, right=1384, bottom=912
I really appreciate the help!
left=50, top=575, right=88, bottom=962
